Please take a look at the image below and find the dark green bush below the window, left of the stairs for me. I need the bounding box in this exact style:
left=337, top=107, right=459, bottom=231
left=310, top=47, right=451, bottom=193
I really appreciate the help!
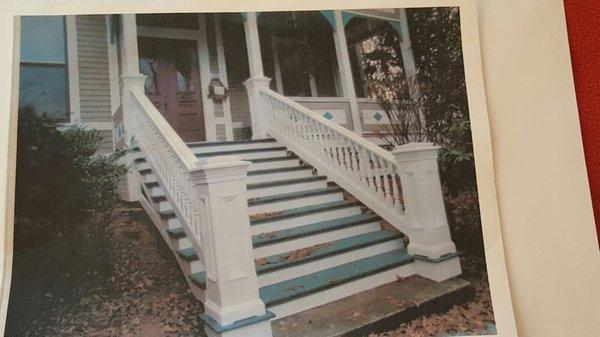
left=15, top=108, right=126, bottom=246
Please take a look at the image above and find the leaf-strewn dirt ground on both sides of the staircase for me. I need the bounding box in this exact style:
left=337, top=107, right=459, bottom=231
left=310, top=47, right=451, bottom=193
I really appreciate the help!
left=5, top=205, right=494, bottom=337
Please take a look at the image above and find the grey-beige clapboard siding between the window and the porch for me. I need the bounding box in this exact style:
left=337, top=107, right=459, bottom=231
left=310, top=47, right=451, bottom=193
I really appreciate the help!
left=77, top=15, right=113, bottom=138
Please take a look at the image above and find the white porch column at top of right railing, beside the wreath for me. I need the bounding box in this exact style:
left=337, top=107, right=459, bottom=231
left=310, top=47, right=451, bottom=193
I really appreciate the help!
left=244, top=12, right=271, bottom=139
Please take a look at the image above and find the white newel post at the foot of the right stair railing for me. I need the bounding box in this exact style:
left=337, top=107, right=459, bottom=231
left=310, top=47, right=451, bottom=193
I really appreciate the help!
left=393, top=143, right=461, bottom=281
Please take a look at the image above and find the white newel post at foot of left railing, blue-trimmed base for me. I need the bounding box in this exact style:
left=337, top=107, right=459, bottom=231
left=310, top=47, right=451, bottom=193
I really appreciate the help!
left=191, top=157, right=274, bottom=337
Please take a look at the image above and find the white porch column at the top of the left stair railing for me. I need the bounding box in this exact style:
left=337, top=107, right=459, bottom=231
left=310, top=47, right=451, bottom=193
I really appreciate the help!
left=120, top=14, right=146, bottom=201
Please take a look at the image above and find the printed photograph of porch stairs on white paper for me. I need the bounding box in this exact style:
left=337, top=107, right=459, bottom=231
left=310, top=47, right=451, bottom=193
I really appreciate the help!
left=5, top=7, right=497, bottom=337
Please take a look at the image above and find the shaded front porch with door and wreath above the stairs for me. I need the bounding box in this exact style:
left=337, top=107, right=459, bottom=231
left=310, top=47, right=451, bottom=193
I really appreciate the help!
left=109, top=9, right=416, bottom=142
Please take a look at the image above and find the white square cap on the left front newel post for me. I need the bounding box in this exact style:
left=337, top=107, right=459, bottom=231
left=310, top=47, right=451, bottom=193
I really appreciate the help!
left=190, top=156, right=250, bottom=183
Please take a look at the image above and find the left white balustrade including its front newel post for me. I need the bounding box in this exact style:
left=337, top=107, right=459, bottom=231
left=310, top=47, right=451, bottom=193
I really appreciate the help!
left=124, top=85, right=273, bottom=337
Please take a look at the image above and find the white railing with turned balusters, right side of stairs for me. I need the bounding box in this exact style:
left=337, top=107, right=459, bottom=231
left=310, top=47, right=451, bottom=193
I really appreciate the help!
left=258, top=88, right=412, bottom=236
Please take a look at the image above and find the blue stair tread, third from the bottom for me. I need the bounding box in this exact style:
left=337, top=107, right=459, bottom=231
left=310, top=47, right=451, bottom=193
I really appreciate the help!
left=252, top=214, right=381, bottom=248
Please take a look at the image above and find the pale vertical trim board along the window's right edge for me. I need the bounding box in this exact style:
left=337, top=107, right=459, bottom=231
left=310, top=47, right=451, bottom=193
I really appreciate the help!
left=65, top=15, right=81, bottom=124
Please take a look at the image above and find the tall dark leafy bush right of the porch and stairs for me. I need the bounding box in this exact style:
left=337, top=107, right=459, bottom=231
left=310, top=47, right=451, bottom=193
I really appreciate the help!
left=365, top=7, right=483, bottom=255
